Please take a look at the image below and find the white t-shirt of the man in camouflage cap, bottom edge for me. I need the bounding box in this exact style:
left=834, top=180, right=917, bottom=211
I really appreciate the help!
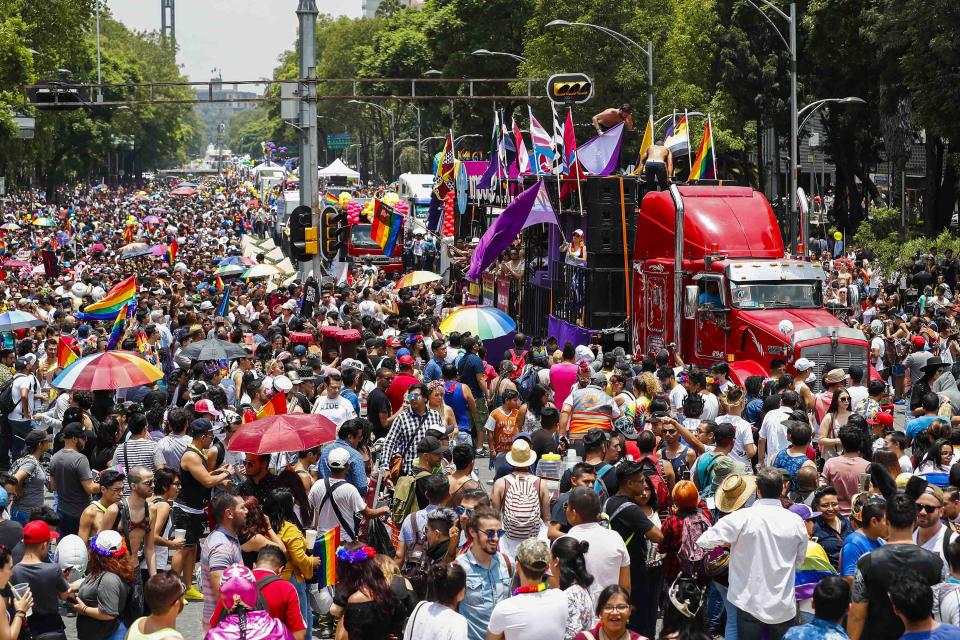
left=487, top=588, right=568, bottom=640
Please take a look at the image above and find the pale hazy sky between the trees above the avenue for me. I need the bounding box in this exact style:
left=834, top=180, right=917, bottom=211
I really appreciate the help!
left=106, top=0, right=360, bottom=82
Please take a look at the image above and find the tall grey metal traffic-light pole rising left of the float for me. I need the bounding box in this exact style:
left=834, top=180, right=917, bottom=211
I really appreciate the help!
left=297, top=0, right=323, bottom=281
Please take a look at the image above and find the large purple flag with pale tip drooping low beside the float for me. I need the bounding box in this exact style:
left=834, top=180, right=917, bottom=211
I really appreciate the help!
left=467, top=181, right=560, bottom=281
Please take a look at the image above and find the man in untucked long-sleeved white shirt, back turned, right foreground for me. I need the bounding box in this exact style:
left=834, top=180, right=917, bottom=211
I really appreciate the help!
left=697, top=467, right=807, bottom=640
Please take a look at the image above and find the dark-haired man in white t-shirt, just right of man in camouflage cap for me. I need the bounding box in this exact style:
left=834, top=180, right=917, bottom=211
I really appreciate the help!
left=566, top=487, right=630, bottom=604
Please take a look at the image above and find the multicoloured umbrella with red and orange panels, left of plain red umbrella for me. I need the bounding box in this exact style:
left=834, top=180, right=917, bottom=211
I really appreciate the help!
left=53, top=351, right=163, bottom=391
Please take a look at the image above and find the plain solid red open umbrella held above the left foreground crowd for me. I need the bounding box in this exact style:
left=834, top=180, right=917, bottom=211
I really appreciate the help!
left=227, top=413, right=337, bottom=453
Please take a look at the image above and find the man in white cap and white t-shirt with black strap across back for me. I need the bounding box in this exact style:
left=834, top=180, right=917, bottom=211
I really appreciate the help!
left=308, top=447, right=390, bottom=542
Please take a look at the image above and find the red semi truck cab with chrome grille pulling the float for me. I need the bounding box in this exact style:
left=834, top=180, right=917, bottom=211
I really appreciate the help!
left=632, top=185, right=869, bottom=386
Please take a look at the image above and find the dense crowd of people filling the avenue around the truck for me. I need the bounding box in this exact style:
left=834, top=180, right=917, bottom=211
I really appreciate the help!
left=0, top=178, right=960, bottom=640
